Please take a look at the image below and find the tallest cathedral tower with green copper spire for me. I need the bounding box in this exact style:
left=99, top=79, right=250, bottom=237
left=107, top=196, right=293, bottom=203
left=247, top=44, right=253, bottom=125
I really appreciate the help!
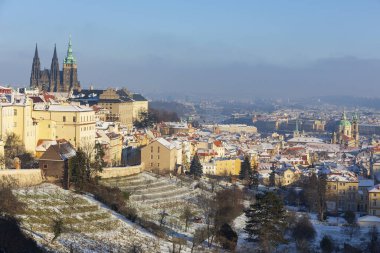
left=62, top=36, right=80, bottom=92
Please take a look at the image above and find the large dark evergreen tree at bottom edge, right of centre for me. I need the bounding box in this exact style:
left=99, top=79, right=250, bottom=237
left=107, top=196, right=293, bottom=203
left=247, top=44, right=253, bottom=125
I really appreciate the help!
left=244, top=192, right=286, bottom=253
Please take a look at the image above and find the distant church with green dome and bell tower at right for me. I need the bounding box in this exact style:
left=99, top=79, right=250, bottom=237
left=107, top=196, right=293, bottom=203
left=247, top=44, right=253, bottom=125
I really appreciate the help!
left=332, top=112, right=359, bottom=147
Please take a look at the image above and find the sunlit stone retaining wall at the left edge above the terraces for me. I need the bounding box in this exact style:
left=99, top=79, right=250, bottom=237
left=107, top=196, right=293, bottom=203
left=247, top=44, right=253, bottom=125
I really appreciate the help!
left=0, top=169, right=43, bottom=187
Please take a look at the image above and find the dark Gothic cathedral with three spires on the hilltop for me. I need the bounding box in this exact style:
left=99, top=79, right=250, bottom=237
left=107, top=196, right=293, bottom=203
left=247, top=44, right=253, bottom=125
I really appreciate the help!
left=30, top=37, right=80, bottom=92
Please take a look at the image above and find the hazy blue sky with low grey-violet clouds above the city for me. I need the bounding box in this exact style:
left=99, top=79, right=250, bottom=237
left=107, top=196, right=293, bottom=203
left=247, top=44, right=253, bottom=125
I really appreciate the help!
left=0, top=0, right=380, bottom=98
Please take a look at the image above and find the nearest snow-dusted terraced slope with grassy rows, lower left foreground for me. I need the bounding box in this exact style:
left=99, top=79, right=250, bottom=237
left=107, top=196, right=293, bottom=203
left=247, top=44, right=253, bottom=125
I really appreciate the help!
left=14, top=184, right=188, bottom=252
